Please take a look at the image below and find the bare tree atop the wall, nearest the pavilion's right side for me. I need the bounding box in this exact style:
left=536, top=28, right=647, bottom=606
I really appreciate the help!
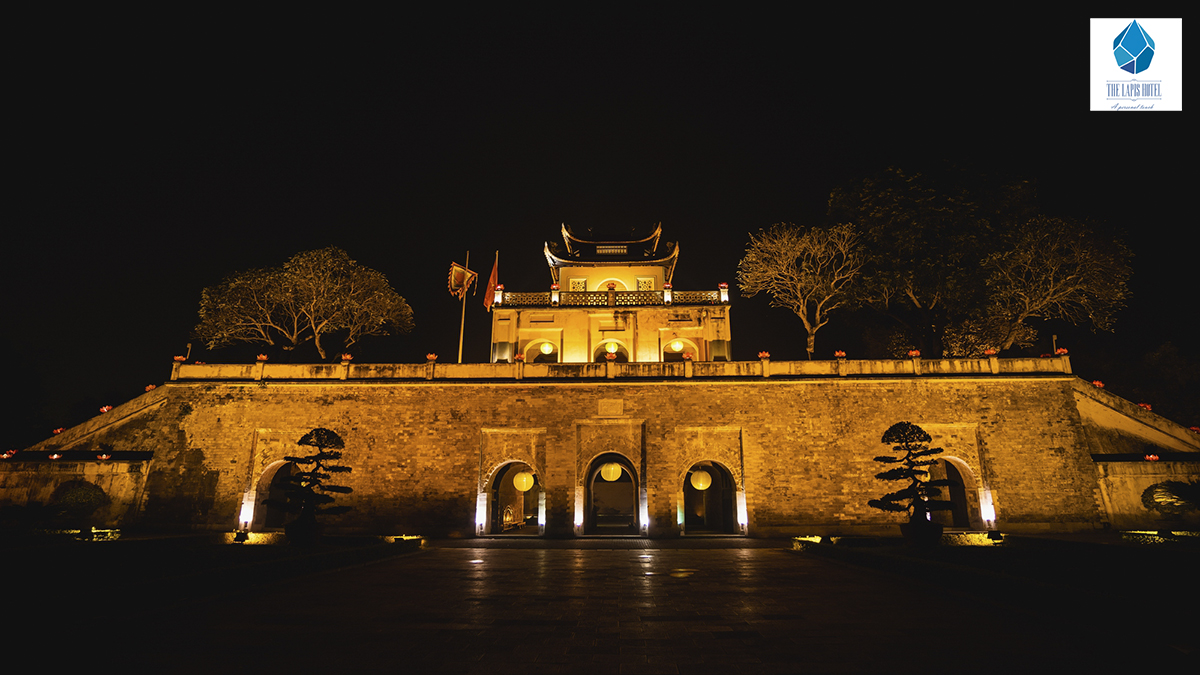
left=738, top=223, right=863, bottom=359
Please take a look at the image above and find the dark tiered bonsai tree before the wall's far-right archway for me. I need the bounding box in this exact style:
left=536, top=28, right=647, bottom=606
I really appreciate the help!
left=866, top=422, right=954, bottom=536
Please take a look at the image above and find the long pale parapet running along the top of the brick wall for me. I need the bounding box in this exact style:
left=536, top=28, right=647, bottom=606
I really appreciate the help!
left=170, top=356, right=1070, bottom=381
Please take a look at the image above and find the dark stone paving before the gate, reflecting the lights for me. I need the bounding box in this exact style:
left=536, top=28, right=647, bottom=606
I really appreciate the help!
left=127, top=539, right=1178, bottom=674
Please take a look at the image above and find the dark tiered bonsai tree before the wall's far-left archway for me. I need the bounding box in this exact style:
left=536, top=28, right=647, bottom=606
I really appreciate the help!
left=269, top=428, right=353, bottom=544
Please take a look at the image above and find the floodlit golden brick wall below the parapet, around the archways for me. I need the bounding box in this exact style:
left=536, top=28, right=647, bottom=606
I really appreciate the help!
left=9, top=364, right=1200, bottom=537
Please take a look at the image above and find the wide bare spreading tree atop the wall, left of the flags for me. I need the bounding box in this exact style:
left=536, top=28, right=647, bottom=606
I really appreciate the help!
left=196, top=246, right=413, bottom=359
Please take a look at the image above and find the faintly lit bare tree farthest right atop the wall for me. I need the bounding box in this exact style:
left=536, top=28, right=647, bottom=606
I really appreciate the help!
left=983, top=216, right=1132, bottom=350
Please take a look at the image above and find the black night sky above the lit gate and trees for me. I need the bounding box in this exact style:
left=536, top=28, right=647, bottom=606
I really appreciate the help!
left=0, top=13, right=1198, bottom=447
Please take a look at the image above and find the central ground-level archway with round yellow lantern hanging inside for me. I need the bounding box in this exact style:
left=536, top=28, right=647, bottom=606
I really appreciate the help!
left=583, top=453, right=640, bottom=534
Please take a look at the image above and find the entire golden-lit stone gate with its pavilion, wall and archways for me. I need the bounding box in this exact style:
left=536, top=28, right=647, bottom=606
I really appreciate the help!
left=0, top=228, right=1200, bottom=537
